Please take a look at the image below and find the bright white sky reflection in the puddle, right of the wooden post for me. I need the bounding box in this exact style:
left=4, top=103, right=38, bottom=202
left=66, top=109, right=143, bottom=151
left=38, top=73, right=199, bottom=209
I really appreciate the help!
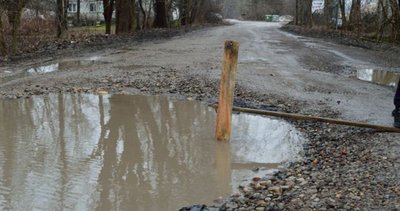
left=232, top=114, right=303, bottom=163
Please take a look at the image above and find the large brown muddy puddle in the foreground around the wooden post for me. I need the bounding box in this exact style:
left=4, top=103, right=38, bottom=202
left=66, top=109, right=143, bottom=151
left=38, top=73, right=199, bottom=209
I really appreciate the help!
left=0, top=94, right=304, bottom=210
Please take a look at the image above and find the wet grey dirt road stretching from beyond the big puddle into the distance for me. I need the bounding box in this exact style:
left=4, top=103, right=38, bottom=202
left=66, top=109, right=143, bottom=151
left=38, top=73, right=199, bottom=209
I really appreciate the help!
left=0, top=21, right=400, bottom=125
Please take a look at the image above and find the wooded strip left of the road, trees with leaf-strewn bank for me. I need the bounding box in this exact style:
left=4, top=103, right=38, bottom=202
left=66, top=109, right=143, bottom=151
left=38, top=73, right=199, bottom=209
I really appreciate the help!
left=0, top=0, right=222, bottom=60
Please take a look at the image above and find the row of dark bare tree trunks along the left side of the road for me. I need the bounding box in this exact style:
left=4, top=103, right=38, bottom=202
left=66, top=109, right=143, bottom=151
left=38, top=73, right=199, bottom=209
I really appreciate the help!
left=0, top=0, right=224, bottom=56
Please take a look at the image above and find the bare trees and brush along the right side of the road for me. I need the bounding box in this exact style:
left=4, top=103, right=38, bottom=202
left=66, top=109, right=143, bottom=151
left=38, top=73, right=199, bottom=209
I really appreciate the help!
left=295, top=0, right=400, bottom=42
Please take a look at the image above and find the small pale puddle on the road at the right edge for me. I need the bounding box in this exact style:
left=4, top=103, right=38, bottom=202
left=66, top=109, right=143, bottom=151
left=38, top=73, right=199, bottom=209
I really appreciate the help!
left=357, top=69, right=400, bottom=87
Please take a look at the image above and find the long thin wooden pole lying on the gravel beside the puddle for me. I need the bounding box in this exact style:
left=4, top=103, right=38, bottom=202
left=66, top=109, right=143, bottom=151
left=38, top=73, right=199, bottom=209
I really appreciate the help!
left=219, top=105, right=400, bottom=133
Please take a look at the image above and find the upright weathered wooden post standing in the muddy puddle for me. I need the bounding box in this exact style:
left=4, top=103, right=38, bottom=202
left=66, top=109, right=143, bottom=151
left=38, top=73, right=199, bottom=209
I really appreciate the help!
left=215, top=40, right=239, bottom=141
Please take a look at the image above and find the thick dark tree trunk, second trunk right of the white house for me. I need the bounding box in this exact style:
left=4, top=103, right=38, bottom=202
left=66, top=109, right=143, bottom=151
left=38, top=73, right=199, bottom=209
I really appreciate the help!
left=115, top=0, right=135, bottom=34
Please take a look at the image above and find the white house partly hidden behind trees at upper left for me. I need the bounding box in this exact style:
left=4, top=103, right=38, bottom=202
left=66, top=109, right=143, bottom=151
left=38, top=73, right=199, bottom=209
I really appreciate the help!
left=68, top=0, right=104, bottom=23
